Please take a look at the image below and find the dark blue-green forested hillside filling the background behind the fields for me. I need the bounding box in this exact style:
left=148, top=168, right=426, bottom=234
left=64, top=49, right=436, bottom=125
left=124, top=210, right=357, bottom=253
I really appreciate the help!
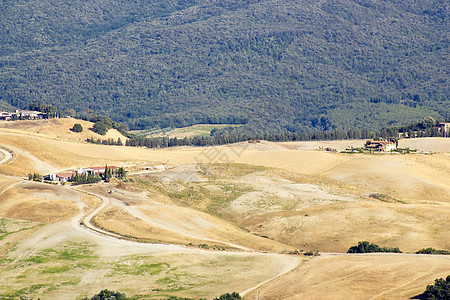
left=0, top=0, right=450, bottom=131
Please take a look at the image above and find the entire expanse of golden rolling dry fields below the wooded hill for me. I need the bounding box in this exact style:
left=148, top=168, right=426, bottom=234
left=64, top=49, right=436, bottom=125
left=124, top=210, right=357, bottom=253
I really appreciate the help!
left=0, top=119, right=450, bottom=299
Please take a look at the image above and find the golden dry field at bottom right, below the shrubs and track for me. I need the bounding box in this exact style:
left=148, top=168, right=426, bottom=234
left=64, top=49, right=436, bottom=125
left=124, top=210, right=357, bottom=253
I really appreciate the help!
left=244, top=253, right=450, bottom=300
